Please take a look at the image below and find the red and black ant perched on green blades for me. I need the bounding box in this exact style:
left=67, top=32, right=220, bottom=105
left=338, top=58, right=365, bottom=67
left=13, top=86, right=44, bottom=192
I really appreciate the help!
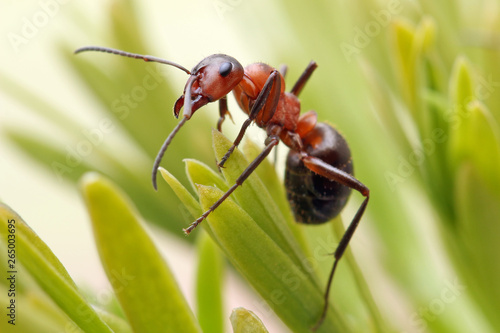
left=75, top=46, right=370, bottom=331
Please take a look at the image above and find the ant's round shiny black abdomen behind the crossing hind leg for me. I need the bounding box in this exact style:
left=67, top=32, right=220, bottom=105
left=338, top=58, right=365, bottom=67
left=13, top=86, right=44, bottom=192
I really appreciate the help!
left=285, top=123, right=353, bottom=224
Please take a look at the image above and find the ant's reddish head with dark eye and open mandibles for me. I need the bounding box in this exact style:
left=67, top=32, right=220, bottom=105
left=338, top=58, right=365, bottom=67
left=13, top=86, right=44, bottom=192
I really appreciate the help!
left=174, top=54, right=244, bottom=118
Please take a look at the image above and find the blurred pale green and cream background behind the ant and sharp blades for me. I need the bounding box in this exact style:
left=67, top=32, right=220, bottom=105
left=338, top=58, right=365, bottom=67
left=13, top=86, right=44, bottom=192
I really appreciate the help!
left=0, top=0, right=500, bottom=332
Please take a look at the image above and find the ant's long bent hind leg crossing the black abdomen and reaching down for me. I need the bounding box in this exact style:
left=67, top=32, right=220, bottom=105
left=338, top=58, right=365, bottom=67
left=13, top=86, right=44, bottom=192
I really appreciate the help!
left=302, top=154, right=370, bottom=331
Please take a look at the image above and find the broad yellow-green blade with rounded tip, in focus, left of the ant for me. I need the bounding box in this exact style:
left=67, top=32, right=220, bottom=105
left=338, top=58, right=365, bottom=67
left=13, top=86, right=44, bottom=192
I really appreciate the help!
left=81, top=174, right=201, bottom=333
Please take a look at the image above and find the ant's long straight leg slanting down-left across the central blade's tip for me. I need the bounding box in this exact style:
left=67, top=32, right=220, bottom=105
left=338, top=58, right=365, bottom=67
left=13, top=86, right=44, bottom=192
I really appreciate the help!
left=184, top=135, right=280, bottom=235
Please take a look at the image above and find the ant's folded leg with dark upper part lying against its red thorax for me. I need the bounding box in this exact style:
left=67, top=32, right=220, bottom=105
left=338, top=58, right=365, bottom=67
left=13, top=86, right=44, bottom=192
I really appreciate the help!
left=217, top=70, right=281, bottom=168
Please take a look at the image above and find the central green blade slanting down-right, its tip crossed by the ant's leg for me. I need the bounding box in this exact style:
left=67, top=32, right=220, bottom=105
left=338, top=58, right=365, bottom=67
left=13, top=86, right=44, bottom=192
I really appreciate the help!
left=199, top=185, right=348, bottom=332
